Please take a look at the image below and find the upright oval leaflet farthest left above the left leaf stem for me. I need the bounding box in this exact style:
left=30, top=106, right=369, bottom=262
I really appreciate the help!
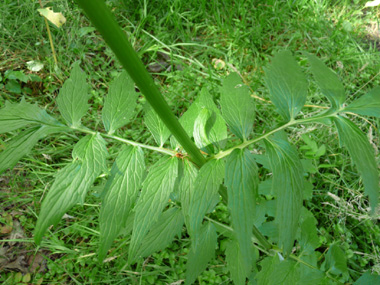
left=57, top=62, right=90, bottom=127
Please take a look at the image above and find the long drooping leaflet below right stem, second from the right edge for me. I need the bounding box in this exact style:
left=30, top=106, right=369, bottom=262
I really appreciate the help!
left=265, top=133, right=304, bottom=255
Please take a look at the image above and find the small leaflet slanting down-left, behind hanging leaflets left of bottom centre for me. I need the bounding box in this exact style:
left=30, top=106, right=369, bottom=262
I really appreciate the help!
left=136, top=208, right=183, bottom=257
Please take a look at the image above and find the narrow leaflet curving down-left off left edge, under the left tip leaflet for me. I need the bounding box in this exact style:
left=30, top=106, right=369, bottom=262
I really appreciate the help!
left=0, top=126, right=61, bottom=174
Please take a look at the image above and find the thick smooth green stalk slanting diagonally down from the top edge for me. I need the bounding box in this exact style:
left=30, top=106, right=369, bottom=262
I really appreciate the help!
left=76, top=0, right=206, bottom=166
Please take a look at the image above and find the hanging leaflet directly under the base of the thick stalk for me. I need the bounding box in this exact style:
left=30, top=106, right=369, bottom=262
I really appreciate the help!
left=188, top=159, right=225, bottom=236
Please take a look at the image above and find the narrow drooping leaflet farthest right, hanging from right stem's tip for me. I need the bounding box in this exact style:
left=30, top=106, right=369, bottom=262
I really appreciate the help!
left=334, top=116, right=379, bottom=213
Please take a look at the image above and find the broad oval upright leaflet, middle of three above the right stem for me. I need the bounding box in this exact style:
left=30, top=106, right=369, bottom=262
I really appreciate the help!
left=264, top=51, right=307, bottom=121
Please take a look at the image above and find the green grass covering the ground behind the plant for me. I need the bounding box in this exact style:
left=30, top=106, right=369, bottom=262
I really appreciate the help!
left=0, top=0, right=380, bottom=284
